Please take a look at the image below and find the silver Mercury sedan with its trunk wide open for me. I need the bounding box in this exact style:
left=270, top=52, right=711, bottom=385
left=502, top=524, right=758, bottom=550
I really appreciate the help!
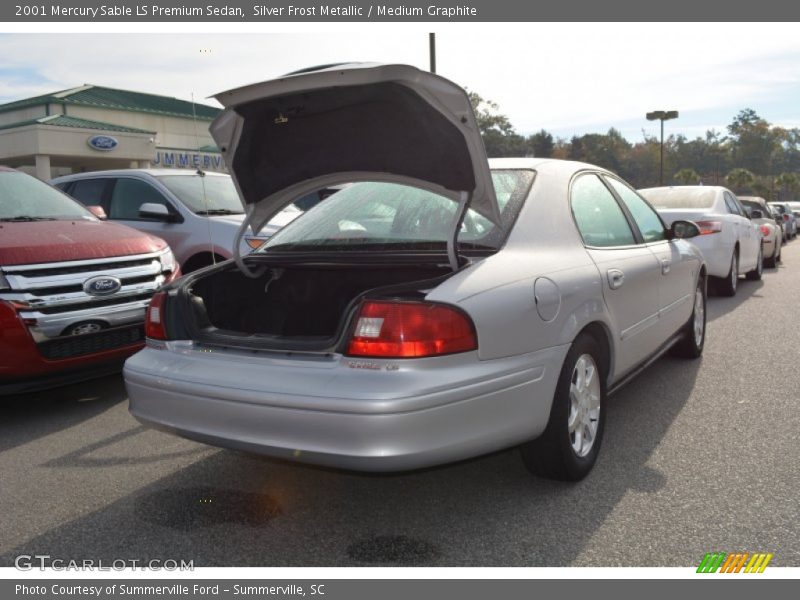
left=125, top=65, right=706, bottom=480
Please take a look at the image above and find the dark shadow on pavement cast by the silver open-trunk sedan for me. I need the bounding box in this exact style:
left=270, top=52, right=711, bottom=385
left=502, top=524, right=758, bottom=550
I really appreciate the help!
left=0, top=358, right=702, bottom=566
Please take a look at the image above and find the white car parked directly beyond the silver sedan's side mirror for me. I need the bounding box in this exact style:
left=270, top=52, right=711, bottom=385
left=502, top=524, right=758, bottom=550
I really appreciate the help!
left=639, top=185, right=763, bottom=296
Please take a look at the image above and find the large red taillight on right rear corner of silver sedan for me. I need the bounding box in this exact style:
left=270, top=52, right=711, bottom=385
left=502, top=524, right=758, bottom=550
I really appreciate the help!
left=347, top=300, right=478, bottom=358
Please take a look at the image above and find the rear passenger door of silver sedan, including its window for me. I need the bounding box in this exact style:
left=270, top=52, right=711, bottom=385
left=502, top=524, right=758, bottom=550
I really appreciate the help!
left=570, top=172, right=662, bottom=377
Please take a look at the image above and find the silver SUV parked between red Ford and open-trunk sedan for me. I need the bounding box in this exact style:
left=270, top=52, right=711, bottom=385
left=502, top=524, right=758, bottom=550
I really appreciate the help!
left=50, top=169, right=303, bottom=273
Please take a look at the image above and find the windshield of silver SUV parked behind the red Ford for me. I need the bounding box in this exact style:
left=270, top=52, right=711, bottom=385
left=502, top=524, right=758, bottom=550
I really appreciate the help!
left=158, top=174, right=244, bottom=215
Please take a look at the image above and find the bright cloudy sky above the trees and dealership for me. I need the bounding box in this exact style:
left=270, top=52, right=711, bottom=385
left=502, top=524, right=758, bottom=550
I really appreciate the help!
left=0, top=23, right=800, bottom=141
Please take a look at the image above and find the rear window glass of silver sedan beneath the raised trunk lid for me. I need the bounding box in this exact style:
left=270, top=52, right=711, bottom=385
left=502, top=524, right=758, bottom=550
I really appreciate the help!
left=259, top=169, right=534, bottom=252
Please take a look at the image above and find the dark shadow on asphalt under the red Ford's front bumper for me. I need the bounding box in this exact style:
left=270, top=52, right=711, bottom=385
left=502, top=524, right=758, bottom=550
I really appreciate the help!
left=0, top=374, right=128, bottom=452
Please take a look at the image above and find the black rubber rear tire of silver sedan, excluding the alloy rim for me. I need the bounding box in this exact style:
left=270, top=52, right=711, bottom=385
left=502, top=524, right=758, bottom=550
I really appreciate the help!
left=520, top=333, right=608, bottom=481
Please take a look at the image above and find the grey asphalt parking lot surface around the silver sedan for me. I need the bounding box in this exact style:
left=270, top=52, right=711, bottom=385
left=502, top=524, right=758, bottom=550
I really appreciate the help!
left=0, top=240, right=800, bottom=566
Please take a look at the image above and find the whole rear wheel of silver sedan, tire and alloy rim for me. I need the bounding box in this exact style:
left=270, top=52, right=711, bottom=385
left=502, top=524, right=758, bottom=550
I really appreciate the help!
left=520, top=333, right=608, bottom=481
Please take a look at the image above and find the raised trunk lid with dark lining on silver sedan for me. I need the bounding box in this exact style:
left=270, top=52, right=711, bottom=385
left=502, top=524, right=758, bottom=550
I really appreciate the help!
left=210, top=63, right=501, bottom=239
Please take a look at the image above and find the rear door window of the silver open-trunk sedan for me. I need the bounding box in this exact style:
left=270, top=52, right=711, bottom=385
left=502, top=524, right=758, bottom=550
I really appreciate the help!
left=570, top=175, right=636, bottom=248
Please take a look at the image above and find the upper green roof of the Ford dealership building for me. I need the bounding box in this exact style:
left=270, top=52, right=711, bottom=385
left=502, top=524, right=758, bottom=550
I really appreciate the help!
left=0, top=85, right=221, bottom=121
